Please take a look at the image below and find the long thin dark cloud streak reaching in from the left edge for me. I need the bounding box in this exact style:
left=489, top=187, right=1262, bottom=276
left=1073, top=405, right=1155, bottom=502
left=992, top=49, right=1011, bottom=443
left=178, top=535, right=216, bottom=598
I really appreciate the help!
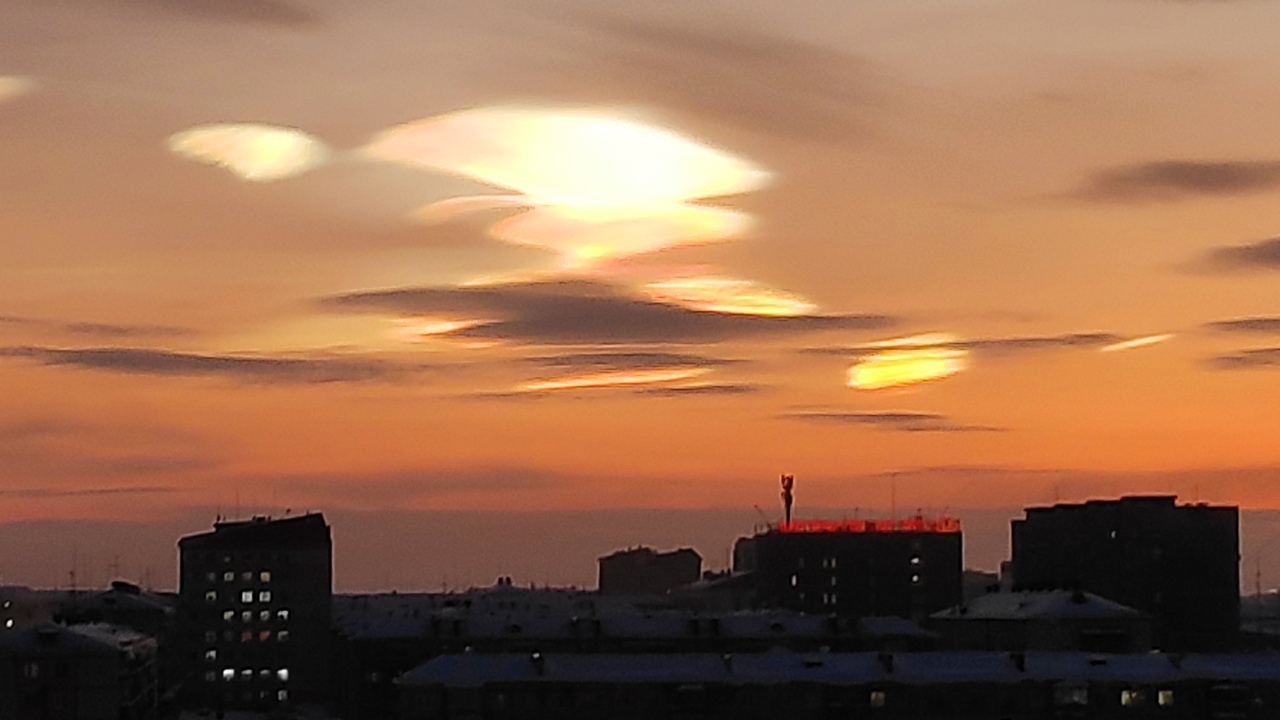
left=0, top=346, right=404, bottom=384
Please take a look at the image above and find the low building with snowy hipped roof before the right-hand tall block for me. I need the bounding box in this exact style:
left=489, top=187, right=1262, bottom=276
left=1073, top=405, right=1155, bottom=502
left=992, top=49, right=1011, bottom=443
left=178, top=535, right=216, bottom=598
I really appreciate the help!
left=928, top=591, right=1151, bottom=652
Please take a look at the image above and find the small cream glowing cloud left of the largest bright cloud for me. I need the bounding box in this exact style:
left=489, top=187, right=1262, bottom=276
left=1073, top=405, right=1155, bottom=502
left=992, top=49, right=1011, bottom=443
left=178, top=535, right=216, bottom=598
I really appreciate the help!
left=169, top=123, right=329, bottom=182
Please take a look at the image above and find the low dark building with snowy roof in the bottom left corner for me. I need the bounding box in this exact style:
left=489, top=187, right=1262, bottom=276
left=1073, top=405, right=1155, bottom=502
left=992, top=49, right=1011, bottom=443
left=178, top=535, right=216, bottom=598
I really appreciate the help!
left=0, top=623, right=159, bottom=720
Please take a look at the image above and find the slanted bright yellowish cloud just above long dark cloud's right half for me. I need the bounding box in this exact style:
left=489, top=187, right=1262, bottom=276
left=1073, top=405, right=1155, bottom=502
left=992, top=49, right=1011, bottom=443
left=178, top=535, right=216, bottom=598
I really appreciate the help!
left=644, top=275, right=818, bottom=318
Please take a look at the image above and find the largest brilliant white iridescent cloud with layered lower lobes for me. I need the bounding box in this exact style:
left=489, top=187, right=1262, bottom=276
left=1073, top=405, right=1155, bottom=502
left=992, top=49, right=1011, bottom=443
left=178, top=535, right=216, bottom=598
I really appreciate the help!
left=364, top=108, right=769, bottom=269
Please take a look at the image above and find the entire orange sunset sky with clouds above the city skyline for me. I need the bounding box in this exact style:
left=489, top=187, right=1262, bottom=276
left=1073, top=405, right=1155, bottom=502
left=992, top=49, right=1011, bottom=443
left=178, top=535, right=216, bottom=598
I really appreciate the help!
left=0, top=0, right=1280, bottom=588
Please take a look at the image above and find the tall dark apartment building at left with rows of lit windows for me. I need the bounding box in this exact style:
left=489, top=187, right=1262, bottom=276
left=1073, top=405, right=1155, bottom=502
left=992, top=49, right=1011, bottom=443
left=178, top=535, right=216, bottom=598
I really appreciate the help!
left=178, top=514, right=333, bottom=710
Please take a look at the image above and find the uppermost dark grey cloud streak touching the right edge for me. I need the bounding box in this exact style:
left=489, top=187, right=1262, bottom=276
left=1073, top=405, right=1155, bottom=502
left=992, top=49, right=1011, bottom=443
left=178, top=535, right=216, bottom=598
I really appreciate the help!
left=1076, top=160, right=1280, bottom=202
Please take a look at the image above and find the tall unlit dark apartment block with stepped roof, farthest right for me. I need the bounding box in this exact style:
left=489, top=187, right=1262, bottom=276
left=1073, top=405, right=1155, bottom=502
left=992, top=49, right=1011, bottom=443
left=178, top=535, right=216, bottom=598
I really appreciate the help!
left=1012, top=496, right=1240, bottom=650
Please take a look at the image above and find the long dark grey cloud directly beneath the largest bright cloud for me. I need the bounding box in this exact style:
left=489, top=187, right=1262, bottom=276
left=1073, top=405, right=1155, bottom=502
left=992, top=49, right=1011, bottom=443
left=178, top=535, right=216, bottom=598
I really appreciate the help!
left=320, top=281, right=896, bottom=345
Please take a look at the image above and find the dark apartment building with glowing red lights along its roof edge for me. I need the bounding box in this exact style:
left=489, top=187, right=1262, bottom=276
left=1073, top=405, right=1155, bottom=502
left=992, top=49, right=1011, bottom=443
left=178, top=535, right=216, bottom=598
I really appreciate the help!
left=750, top=518, right=963, bottom=619
